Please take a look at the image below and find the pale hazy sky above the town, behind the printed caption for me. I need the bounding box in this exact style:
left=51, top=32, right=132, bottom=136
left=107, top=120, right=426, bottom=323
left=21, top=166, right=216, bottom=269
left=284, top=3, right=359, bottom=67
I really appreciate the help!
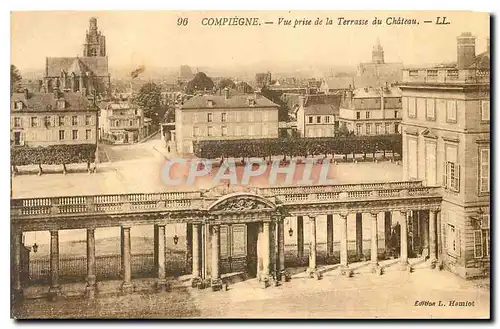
left=11, top=11, right=489, bottom=72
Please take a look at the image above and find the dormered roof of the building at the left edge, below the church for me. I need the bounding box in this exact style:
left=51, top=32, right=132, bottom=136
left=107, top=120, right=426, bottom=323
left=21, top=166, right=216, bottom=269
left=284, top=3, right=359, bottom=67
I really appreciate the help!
left=11, top=92, right=97, bottom=112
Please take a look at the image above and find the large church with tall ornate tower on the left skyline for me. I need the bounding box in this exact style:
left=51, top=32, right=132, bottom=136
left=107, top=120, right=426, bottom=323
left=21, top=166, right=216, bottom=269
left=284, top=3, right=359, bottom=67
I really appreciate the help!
left=42, top=17, right=111, bottom=96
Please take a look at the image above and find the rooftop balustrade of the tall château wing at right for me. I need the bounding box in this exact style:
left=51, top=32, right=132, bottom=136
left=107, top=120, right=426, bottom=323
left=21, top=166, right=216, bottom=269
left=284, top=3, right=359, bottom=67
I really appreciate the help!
left=403, top=68, right=490, bottom=84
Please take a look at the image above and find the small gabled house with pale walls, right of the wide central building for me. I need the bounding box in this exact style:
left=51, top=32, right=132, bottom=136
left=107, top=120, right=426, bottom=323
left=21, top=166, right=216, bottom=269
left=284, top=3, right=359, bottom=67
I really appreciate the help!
left=297, top=94, right=341, bottom=137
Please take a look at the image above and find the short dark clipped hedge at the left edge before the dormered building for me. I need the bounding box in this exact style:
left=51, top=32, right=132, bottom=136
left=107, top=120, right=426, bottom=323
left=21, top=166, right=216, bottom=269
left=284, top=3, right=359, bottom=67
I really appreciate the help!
left=10, top=144, right=96, bottom=166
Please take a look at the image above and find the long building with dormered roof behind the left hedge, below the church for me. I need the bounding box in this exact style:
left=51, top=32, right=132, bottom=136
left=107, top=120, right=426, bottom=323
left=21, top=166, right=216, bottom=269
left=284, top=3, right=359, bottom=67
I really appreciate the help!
left=10, top=90, right=98, bottom=147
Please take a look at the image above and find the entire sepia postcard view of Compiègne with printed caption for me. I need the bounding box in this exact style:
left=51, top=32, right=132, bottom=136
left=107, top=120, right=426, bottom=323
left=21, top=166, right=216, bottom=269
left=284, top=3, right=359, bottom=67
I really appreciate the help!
left=5, top=11, right=491, bottom=320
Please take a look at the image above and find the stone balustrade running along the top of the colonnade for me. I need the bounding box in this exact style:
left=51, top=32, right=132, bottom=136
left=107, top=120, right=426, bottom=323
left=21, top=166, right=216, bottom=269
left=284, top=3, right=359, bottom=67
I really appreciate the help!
left=11, top=181, right=439, bottom=218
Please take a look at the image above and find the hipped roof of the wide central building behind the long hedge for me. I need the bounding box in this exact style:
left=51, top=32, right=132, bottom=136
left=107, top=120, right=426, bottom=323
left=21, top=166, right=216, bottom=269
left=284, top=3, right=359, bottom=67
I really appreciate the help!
left=182, top=95, right=278, bottom=109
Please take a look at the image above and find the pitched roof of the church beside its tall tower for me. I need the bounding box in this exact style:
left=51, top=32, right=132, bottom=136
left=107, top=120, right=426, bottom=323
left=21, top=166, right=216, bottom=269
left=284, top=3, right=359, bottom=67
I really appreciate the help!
left=45, top=56, right=109, bottom=77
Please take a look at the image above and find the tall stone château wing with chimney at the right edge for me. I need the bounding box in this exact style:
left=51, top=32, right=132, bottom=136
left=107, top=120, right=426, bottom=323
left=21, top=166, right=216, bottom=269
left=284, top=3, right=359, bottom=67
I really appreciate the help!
left=401, top=33, right=490, bottom=278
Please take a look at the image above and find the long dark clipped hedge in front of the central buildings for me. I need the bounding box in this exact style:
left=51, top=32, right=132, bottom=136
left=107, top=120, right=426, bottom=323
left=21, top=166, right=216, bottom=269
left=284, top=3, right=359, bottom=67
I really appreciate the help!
left=193, top=134, right=402, bottom=159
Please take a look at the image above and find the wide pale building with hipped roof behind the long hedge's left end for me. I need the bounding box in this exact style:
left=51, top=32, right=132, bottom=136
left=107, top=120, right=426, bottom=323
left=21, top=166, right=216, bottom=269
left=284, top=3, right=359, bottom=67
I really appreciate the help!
left=172, top=89, right=278, bottom=154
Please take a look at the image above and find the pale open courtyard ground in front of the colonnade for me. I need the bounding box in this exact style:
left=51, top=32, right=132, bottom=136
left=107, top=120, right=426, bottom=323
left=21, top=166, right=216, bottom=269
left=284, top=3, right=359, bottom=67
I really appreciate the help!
left=16, top=264, right=490, bottom=318
